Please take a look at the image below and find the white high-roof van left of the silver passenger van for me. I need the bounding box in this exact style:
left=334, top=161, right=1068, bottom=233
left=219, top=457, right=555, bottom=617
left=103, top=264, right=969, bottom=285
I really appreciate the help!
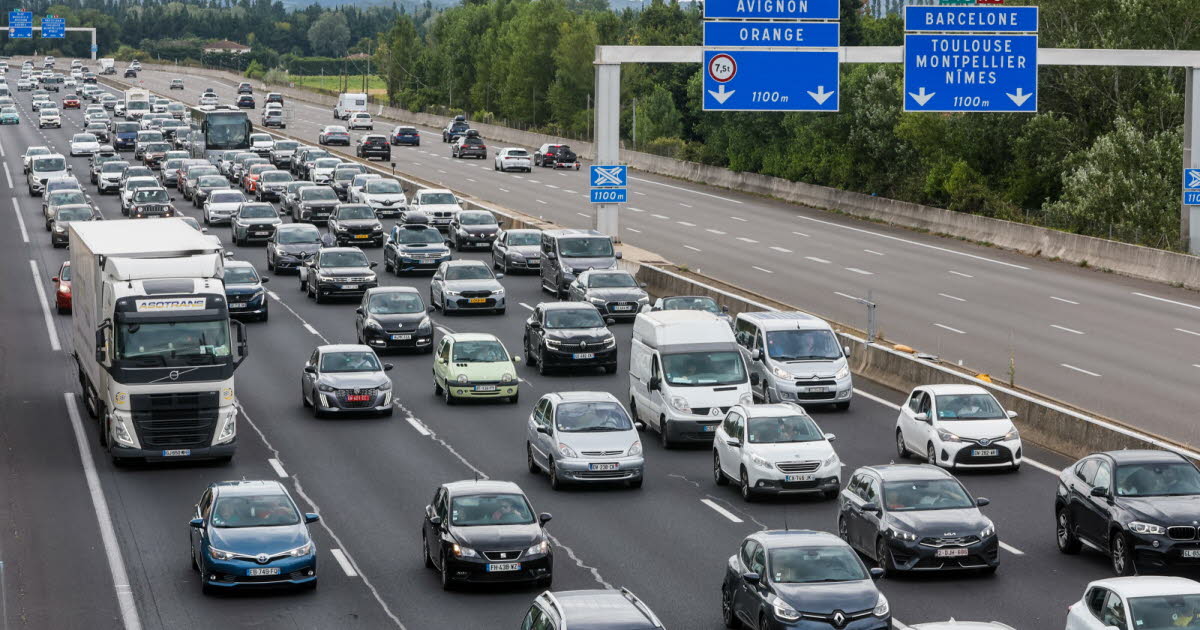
left=629, top=311, right=754, bottom=448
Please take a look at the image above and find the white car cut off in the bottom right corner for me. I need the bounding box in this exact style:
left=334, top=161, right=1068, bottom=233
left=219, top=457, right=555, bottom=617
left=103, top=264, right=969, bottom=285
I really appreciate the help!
left=1067, top=575, right=1200, bottom=630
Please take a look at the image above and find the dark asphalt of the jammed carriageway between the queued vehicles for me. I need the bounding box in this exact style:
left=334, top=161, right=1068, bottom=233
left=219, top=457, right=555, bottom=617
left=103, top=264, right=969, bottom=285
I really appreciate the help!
left=0, top=72, right=1110, bottom=630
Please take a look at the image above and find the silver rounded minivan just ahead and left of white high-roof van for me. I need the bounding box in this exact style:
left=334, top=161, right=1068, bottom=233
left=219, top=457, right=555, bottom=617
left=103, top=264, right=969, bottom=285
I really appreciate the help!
left=526, top=391, right=646, bottom=490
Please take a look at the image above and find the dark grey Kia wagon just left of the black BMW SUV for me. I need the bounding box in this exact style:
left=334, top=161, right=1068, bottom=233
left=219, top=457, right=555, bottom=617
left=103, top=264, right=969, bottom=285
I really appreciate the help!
left=838, top=464, right=1000, bottom=574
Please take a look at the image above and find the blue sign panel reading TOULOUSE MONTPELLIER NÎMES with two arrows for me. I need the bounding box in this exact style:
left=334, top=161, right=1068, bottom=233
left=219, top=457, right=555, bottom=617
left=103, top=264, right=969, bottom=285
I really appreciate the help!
left=904, top=34, right=1038, bottom=113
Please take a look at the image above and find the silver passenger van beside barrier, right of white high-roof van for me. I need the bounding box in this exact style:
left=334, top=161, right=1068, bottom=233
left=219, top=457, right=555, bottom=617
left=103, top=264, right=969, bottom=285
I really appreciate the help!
left=733, top=312, right=854, bottom=409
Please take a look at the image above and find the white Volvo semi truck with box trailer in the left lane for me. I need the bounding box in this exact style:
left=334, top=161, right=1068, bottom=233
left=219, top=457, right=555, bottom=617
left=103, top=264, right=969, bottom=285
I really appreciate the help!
left=70, top=218, right=247, bottom=462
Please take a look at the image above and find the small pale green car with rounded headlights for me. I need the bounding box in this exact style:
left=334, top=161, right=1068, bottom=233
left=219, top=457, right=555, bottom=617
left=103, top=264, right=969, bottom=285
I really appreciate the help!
left=433, top=332, right=521, bottom=404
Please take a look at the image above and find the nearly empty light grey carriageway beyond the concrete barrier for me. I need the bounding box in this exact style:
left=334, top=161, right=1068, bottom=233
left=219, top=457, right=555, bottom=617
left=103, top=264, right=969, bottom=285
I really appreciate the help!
left=121, top=68, right=1200, bottom=445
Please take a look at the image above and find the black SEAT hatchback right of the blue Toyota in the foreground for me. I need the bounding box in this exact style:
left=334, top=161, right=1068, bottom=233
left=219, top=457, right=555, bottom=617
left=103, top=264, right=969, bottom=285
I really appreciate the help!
left=421, top=480, right=554, bottom=590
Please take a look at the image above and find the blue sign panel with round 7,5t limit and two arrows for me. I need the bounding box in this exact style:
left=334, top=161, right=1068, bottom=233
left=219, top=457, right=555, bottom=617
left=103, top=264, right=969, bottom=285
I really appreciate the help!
left=703, top=50, right=840, bottom=112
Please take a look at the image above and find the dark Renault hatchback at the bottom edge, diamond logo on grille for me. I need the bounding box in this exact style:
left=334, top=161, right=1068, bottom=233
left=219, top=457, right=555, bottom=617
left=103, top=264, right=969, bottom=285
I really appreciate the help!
left=721, top=529, right=892, bottom=630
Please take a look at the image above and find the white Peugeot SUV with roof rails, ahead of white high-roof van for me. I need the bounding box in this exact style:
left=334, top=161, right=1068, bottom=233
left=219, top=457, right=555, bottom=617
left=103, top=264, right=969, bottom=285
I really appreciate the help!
left=713, top=402, right=842, bottom=502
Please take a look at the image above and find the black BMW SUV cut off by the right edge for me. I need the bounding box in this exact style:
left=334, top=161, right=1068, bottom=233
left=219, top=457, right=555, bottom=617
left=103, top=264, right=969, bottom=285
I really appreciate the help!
left=1055, top=450, right=1200, bottom=575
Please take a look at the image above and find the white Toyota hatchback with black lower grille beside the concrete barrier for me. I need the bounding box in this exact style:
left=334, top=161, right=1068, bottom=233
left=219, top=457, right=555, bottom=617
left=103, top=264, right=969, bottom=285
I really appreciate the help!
left=895, top=385, right=1021, bottom=470
